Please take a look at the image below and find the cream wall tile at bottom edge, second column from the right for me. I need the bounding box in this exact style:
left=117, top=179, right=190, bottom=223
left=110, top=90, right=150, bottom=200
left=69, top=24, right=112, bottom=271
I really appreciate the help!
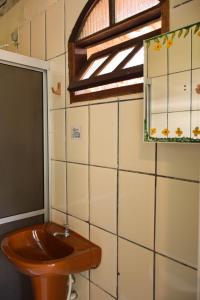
left=119, top=239, right=153, bottom=300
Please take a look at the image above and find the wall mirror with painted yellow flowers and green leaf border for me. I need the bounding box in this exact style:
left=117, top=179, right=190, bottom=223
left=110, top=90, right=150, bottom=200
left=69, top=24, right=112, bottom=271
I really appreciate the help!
left=144, top=23, right=200, bottom=143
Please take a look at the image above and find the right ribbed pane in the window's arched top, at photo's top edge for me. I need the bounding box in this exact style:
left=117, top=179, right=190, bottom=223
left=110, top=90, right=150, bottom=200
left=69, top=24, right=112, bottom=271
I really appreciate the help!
left=115, top=0, right=159, bottom=22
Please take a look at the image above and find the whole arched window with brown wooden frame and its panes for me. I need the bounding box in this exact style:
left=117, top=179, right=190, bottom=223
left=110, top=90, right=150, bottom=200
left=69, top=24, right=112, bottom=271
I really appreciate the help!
left=68, top=0, right=169, bottom=102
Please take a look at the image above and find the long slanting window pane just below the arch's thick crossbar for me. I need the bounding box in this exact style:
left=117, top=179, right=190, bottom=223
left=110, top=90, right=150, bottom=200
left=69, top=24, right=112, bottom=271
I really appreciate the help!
left=87, top=20, right=161, bottom=58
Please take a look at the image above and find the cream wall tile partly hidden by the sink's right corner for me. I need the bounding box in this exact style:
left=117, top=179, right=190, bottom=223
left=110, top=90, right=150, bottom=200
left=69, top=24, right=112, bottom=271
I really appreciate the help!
left=90, top=226, right=117, bottom=300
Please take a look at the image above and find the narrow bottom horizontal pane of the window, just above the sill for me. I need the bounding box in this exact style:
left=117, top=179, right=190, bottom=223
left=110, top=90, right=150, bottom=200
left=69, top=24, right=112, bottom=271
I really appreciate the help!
left=75, top=77, right=144, bottom=95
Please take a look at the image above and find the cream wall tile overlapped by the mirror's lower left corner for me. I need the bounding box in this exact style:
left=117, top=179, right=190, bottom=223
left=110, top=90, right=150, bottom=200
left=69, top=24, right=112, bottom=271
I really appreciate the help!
left=119, top=100, right=155, bottom=173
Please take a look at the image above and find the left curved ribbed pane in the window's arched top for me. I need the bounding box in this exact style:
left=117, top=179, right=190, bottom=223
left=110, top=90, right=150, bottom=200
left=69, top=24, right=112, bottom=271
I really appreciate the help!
left=78, top=0, right=109, bottom=39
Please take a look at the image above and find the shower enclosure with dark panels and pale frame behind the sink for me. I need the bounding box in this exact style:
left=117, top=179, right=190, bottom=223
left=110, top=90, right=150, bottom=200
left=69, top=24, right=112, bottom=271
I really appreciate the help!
left=0, top=50, right=48, bottom=300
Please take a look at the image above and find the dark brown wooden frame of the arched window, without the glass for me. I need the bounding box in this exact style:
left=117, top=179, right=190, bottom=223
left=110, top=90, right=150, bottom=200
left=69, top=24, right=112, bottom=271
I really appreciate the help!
left=68, top=0, right=169, bottom=103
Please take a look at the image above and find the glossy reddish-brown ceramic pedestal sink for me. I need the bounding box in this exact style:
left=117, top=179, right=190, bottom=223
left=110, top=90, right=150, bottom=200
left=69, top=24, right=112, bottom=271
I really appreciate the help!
left=1, top=223, right=101, bottom=300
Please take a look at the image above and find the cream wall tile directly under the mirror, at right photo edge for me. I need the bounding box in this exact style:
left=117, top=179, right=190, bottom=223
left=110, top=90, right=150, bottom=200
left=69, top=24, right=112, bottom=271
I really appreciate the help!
left=157, top=143, right=200, bottom=180
